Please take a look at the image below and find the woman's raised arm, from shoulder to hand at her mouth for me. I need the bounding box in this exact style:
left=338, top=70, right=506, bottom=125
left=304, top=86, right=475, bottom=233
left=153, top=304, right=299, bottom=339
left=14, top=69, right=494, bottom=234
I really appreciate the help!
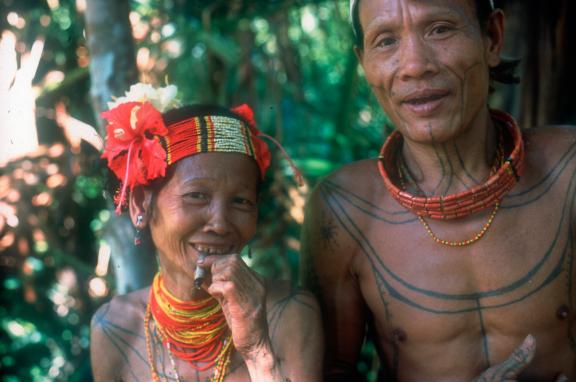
left=201, top=255, right=322, bottom=382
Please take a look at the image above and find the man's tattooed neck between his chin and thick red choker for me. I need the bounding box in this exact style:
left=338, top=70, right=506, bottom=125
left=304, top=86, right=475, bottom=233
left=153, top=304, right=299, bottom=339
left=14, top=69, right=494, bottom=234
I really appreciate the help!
left=397, top=109, right=498, bottom=196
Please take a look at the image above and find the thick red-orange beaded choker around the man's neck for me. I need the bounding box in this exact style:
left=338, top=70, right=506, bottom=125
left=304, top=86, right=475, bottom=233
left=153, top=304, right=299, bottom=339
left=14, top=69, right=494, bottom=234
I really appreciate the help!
left=378, top=110, right=524, bottom=220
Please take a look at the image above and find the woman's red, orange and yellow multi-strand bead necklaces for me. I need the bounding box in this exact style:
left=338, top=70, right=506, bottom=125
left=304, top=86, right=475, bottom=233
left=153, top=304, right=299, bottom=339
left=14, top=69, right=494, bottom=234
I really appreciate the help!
left=144, top=273, right=232, bottom=382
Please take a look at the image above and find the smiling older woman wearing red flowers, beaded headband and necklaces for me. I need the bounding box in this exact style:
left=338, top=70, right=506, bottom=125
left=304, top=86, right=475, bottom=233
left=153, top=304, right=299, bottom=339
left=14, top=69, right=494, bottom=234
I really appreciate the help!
left=91, top=84, right=322, bottom=382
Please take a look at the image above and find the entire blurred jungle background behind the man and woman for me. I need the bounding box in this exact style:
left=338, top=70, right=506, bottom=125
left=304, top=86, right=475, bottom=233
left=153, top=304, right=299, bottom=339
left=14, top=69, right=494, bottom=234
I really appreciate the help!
left=0, top=0, right=576, bottom=381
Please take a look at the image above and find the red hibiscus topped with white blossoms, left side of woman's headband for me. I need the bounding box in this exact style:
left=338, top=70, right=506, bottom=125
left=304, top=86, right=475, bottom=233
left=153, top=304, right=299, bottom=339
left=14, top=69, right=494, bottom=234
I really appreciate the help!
left=101, top=84, right=176, bottom=213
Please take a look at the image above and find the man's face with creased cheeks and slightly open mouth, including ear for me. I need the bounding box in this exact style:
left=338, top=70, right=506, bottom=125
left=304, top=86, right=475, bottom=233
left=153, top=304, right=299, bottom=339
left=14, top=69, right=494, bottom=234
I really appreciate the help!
left=358, top=0, right=499, bottom=143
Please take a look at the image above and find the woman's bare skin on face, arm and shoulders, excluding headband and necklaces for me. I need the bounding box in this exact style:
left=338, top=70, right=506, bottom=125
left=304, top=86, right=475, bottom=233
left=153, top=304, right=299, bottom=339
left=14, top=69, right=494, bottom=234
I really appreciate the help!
left=91, top=153, right=322, bottom=382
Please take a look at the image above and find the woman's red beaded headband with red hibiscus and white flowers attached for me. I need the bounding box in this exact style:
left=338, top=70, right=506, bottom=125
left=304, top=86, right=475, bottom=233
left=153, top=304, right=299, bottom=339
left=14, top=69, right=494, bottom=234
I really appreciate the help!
left=101, top=84, right=302, bottom=213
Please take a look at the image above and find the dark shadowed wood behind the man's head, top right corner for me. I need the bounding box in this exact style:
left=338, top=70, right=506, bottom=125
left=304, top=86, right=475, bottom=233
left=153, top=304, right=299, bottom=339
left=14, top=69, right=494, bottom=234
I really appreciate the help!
left=503, top=0, right=576, bottom=128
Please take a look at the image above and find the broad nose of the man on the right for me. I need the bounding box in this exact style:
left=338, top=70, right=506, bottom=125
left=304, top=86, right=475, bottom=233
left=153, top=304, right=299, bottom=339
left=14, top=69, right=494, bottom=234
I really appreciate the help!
left=397, top=35, right=437, bottom=81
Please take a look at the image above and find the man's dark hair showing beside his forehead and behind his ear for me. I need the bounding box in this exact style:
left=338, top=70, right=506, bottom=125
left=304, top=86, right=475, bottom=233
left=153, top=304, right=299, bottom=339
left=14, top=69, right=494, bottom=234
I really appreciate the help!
left=350, top=0, right=520, bottom=84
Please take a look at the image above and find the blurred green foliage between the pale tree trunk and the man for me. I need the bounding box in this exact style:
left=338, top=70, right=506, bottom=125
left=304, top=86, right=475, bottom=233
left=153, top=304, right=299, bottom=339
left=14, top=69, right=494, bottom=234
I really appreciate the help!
left=129, top=0, right=386, bottom=281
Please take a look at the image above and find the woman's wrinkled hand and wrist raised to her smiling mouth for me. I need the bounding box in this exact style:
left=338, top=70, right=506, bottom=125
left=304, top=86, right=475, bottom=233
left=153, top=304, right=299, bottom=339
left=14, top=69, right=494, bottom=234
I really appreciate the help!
left=198, top=254, right=270, bottom=361
